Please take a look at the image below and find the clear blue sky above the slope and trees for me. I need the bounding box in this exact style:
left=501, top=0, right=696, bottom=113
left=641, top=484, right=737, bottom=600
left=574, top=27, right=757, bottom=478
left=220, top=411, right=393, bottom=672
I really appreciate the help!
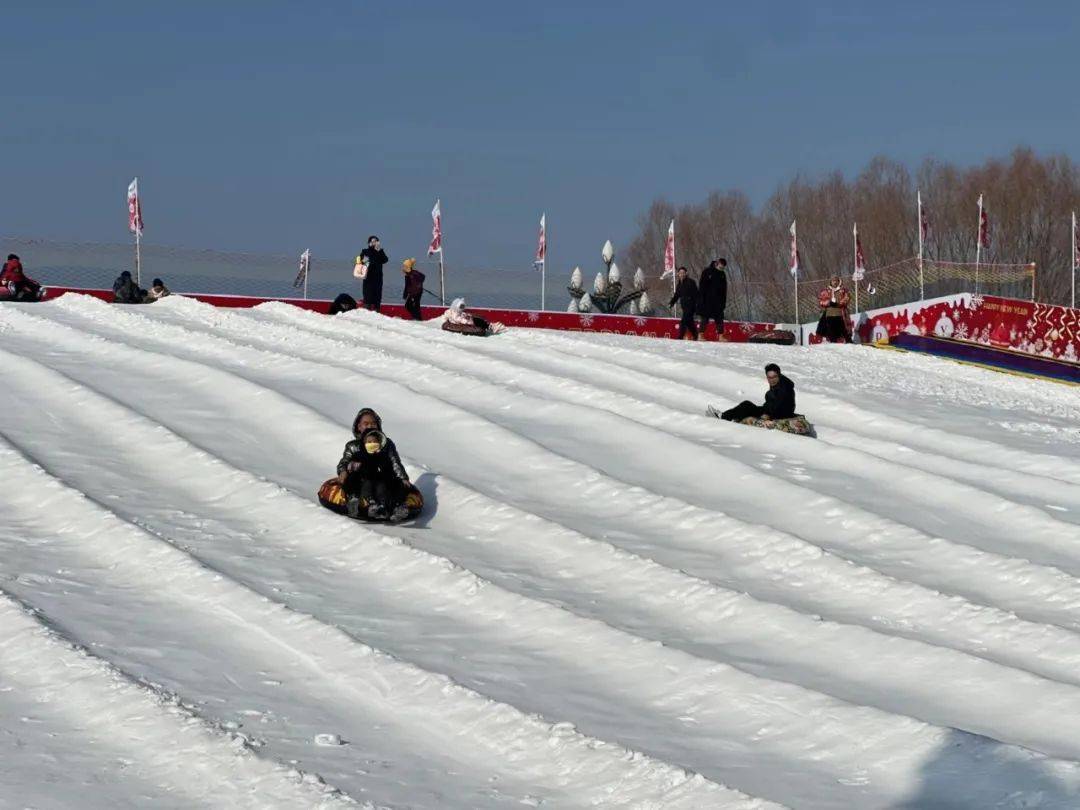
left=0, top=0, right=1080, bottom=273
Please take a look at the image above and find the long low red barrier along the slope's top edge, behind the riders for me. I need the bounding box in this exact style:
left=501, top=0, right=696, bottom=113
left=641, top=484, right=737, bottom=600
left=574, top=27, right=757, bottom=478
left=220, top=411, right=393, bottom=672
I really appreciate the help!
left=38, top=287, right=775, bottom=342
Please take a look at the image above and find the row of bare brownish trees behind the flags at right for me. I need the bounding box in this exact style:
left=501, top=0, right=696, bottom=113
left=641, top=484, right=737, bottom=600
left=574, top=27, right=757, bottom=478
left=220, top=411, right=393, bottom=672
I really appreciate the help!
left=627, top=148, right=1080, bottom=306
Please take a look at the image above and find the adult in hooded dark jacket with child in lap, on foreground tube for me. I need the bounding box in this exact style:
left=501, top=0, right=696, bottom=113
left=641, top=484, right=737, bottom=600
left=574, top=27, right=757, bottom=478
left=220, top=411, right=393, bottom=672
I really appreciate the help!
left=337, top=408, right=409, bottom=523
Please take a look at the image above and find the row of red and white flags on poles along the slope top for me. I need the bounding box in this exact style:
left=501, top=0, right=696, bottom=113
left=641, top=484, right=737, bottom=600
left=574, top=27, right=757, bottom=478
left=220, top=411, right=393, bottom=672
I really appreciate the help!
left=127, top=177, right=1080, bottom=311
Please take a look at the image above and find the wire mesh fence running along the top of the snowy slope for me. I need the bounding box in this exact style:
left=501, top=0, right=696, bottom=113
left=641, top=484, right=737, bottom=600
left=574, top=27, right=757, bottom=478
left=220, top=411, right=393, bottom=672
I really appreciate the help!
left=0, top=237, right=1036, bottom=323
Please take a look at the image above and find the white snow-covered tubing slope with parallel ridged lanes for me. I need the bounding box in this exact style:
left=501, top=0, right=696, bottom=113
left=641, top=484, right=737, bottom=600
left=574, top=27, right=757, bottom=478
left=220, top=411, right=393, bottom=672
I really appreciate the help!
left=0, top=296, right=1080, bottom=810
